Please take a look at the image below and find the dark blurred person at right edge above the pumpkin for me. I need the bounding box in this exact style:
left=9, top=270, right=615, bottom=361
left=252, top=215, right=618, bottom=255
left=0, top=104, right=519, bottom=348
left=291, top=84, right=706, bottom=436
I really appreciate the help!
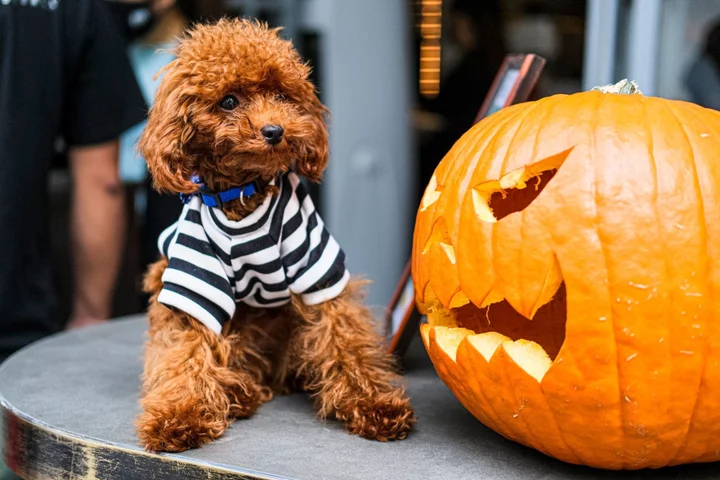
left=685, top=21, right=720, bottom=110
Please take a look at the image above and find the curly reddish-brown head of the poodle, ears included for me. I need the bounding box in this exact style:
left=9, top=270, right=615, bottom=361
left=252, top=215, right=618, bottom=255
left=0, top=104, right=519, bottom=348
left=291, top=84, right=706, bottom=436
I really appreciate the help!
left=140, top=20, right=328, bottom=193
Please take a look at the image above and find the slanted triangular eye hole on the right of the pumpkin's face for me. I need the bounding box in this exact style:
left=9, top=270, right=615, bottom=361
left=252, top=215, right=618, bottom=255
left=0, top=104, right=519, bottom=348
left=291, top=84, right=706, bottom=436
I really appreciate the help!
left=472, top=149, right=572, bottom=223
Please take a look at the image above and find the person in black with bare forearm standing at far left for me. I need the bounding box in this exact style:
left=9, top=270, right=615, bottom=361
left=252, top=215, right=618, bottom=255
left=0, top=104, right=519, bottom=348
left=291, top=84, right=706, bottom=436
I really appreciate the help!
left=0, top=0, right=147, bottom=361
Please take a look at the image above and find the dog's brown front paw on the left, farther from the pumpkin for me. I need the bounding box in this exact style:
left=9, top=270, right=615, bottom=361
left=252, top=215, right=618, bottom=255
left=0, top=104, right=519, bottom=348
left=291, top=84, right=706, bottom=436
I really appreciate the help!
left=137, top=405, right=230, bottom=452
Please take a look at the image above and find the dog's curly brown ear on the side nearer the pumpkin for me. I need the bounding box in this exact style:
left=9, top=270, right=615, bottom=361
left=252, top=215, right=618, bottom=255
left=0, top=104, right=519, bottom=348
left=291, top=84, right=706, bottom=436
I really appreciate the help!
left=295, top=91, right=330, bottom=182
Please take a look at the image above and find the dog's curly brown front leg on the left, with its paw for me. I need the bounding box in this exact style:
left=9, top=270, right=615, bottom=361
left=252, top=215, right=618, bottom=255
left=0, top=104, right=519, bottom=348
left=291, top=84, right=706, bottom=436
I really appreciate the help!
left=136, top=261, right=259, bottom=452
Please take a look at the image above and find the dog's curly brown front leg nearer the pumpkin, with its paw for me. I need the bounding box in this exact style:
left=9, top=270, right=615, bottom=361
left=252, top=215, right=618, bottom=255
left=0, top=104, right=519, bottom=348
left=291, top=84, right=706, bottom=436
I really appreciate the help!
left=290, top=281, right=415, bottom=441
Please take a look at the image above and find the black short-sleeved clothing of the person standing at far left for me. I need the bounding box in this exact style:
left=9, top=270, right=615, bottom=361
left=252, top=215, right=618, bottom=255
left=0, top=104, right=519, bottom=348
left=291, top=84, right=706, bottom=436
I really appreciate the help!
left=0, top=0, right=147, bottom=359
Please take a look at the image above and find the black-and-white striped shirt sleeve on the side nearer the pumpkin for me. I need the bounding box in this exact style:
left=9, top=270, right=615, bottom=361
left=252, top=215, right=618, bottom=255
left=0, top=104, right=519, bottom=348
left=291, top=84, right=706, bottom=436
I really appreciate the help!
left=281, top=175, right=350, bottom=305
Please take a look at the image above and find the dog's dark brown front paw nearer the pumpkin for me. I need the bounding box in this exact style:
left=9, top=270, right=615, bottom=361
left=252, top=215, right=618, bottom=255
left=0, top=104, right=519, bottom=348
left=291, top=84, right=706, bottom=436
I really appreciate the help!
left=346, top=397, right=416, bottom=442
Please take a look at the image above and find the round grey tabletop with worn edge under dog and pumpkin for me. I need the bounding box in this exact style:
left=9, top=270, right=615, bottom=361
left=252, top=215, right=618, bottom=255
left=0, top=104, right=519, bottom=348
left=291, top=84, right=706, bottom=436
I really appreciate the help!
left=0, top=317, right=720, bottom=480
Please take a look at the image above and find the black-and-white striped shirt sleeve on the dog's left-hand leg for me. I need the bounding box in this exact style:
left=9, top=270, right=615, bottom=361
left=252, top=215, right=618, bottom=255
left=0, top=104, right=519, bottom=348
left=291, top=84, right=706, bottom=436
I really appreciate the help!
left=158, top=210, right=235, bottom=334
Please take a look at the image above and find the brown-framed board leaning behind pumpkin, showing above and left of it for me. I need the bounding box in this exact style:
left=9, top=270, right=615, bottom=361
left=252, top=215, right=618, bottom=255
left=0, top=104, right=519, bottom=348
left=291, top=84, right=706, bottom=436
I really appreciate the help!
left=385, top=54, right=546, bottom=357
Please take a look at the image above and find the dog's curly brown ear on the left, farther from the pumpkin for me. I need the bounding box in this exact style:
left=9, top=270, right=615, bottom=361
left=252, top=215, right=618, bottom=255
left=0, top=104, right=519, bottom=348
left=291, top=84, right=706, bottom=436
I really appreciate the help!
left=138, top=60, right=197, bottom=193
